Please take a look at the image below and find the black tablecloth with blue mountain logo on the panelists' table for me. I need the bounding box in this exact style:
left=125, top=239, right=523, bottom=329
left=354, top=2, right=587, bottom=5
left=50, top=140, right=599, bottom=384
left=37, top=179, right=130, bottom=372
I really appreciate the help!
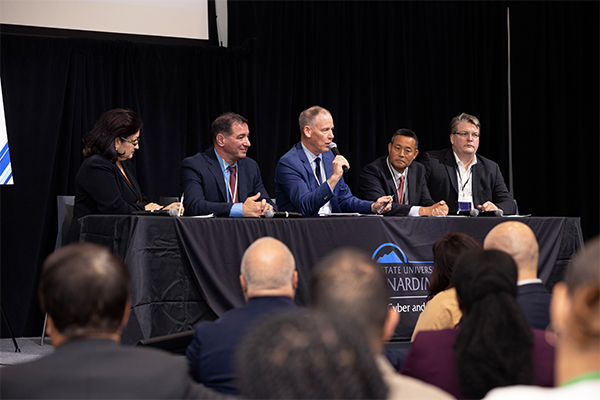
left=80, top=216, right=583, bottom=343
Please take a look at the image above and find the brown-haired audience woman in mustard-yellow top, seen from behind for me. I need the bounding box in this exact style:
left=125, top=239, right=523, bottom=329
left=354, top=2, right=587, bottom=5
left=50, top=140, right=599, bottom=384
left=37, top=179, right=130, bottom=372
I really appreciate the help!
left=411, top=232, right=483, bottom=341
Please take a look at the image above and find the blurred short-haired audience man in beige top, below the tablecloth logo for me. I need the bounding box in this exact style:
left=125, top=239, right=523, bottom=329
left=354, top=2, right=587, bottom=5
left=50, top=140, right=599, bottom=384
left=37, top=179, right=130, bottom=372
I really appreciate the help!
left=309, top=249, right=452, bottom=400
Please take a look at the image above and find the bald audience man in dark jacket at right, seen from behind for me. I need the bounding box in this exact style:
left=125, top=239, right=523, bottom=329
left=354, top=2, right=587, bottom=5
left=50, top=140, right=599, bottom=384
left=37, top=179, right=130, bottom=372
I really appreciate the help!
left=483, top=221, right=552, bottom=329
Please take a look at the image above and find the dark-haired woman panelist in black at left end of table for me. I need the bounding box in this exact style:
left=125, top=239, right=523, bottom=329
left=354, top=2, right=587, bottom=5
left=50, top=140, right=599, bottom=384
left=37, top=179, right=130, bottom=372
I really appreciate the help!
left=67, top=108, right=180, bottom=242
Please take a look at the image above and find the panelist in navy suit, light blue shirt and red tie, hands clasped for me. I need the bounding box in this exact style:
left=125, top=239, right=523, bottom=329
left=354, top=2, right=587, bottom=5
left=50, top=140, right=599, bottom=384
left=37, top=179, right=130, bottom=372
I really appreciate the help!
left=179, top=112, right=273, bottom=217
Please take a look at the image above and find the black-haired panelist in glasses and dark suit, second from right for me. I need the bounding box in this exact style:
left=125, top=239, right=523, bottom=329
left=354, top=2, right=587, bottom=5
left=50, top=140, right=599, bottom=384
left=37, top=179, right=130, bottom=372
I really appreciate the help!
left=358, top=129, right=448, bottom=217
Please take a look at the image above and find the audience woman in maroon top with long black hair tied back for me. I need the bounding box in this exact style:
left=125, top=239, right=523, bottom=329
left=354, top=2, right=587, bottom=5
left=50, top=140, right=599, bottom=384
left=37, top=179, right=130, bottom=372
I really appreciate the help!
left=401, top=250, right=554, bottom=399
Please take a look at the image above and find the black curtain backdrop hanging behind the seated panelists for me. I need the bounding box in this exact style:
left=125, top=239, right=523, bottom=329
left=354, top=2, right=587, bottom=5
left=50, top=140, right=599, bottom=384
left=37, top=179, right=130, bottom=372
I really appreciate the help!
left=0, top=1, right=600, bottom=337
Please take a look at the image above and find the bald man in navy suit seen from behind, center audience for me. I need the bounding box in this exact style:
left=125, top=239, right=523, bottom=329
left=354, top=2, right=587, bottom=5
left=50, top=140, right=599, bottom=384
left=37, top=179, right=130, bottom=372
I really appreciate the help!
left=186, top=237, right=298, bottom=394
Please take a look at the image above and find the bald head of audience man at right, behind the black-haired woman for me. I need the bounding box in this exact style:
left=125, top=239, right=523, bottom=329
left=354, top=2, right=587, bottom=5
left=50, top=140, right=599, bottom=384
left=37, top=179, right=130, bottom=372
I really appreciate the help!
left=483, top=221, right=540, bottom=281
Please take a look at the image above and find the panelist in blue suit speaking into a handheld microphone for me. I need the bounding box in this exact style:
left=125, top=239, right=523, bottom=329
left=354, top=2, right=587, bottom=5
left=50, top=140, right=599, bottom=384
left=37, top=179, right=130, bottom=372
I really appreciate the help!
left=274, top=106, right=392, bottom=215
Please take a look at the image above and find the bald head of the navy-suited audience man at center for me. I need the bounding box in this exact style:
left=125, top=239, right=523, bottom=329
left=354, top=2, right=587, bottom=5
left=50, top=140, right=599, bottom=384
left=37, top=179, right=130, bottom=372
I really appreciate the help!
left=240, top=237, right=298, bottom=300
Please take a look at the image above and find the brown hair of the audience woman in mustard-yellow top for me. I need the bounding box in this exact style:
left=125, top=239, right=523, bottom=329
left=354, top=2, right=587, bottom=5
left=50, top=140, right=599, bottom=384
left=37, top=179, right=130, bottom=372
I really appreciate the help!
left=427, top=232, right=482, bottom=300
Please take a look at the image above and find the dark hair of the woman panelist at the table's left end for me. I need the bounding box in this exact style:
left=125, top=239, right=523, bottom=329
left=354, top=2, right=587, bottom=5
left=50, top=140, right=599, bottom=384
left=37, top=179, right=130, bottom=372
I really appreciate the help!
left=83, top=108, right=144, bottom=162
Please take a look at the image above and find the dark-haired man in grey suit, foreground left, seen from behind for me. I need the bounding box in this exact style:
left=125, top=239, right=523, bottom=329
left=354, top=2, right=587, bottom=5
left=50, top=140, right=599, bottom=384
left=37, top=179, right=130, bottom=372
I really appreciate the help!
left=0, top=243, right=224, bottom=399
